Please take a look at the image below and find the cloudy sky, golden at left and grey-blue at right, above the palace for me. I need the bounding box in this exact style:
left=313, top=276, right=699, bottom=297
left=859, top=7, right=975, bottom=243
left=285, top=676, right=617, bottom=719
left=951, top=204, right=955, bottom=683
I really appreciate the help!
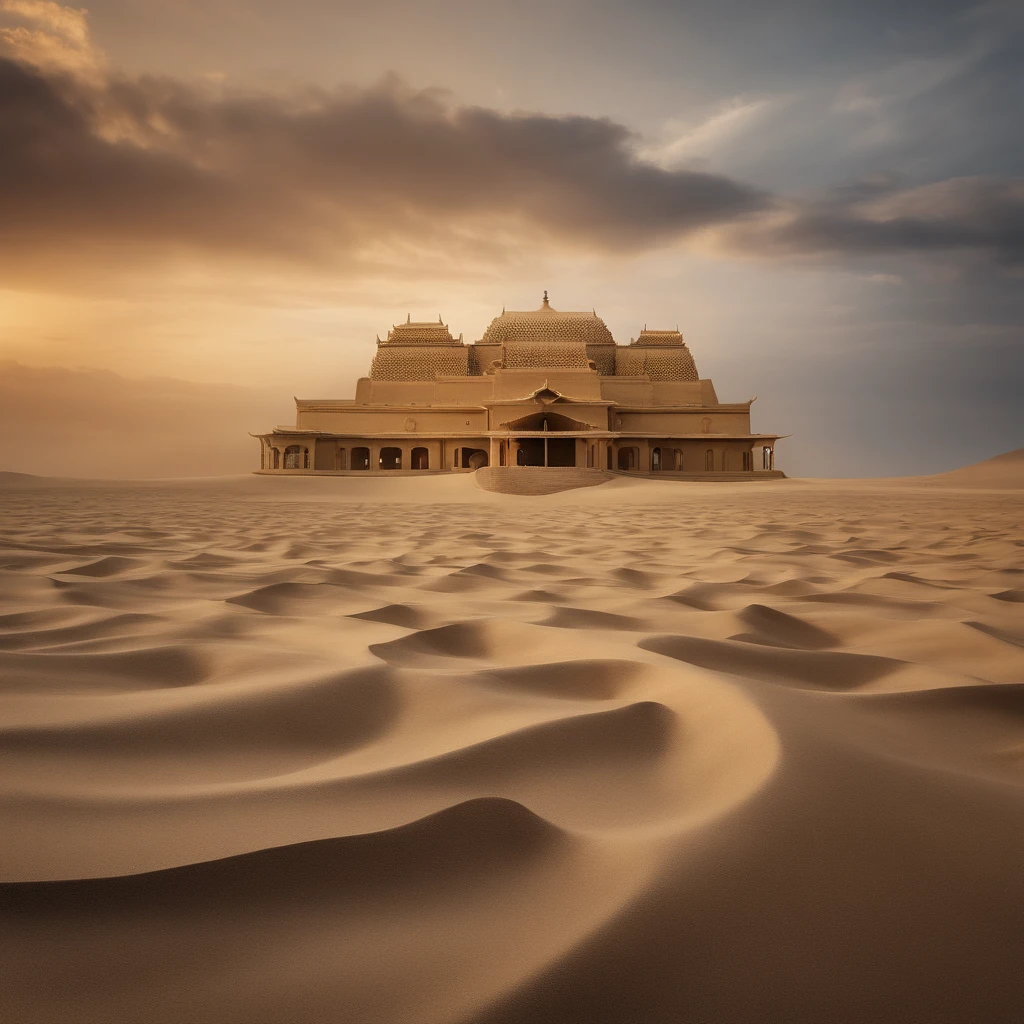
left=0, top=0, right=1024, bottom=477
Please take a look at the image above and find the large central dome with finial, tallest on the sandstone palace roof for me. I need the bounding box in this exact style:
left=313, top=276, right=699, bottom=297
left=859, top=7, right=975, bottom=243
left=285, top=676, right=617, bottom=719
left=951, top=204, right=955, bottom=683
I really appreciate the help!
left=470, top=292, right=615, bottom=375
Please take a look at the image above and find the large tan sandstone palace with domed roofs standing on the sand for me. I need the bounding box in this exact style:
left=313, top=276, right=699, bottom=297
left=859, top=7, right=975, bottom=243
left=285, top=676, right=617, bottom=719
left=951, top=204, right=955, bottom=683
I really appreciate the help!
left=255, top=292, right=782, bottom=489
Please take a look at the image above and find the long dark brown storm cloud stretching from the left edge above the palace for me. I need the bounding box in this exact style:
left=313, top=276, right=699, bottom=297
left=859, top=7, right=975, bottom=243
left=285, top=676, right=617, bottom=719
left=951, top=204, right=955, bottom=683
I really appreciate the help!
left=0, top=60, right=766, bottom=268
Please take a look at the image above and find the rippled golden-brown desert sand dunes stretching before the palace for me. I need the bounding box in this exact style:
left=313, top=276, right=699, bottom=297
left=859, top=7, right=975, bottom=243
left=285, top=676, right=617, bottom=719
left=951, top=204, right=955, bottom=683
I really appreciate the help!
left=0, top=464, right=1024, bottom=1024
